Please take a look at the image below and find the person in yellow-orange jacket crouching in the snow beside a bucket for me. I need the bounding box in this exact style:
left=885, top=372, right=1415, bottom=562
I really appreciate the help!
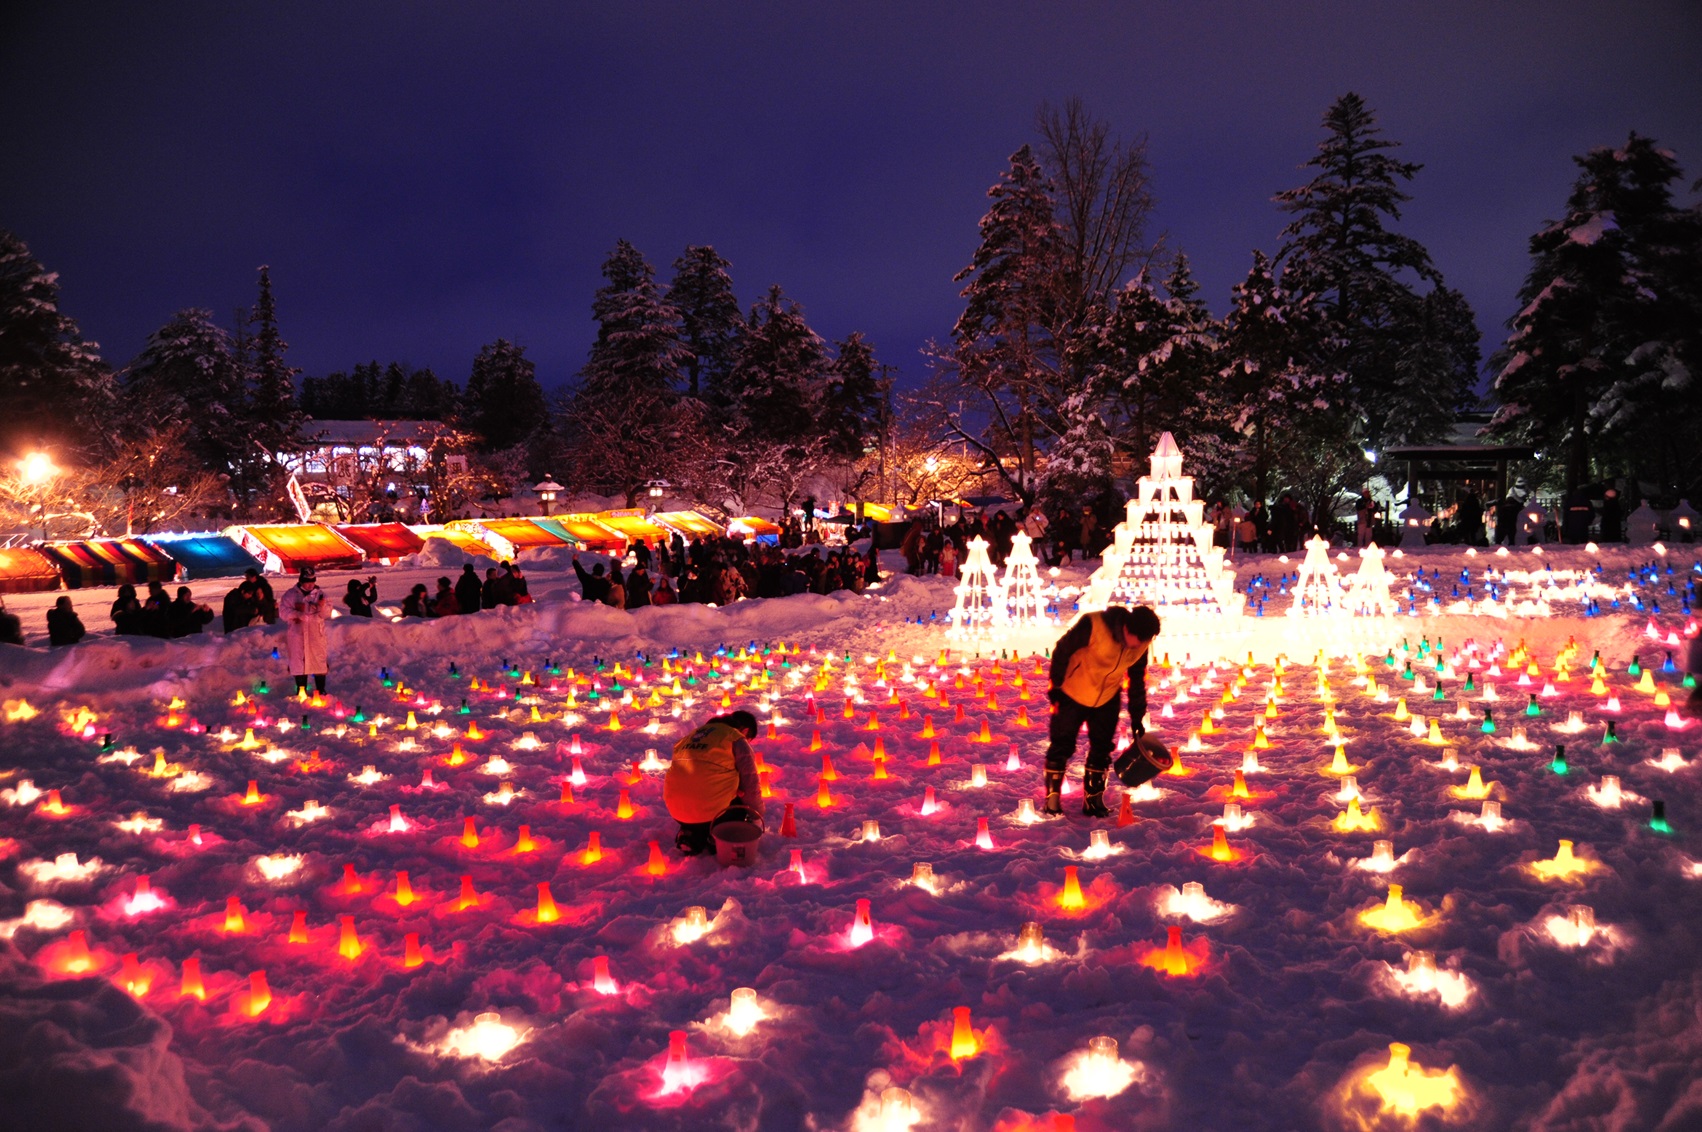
left=662, top=712, right=762, bottom=856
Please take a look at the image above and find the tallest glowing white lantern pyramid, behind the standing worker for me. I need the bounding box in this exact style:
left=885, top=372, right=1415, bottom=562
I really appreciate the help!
left=1081, top=432, right=1246, bottom=615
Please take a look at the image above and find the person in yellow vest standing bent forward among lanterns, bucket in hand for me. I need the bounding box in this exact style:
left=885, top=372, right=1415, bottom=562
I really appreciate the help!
left=1045, top=606, right=1159, bottom=817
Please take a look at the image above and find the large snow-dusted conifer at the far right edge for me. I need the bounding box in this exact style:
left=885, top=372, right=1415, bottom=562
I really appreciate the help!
left=1489, top=133, right=1702, bottom=490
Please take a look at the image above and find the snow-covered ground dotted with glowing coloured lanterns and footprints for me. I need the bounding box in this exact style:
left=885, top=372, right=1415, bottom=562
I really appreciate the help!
left=0, top=546, right=1702, bottom=1132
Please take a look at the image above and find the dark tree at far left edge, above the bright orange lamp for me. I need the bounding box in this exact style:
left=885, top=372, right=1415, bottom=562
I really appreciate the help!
left=0, top=228, right=117, bottom=451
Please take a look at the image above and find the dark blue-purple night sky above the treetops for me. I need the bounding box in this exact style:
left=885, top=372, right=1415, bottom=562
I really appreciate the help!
left=0, top=0, right=1702, bottom=393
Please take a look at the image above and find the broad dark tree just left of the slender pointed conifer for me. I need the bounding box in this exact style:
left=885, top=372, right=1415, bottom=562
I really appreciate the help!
left=124, top=308, right=248, bottom=503
